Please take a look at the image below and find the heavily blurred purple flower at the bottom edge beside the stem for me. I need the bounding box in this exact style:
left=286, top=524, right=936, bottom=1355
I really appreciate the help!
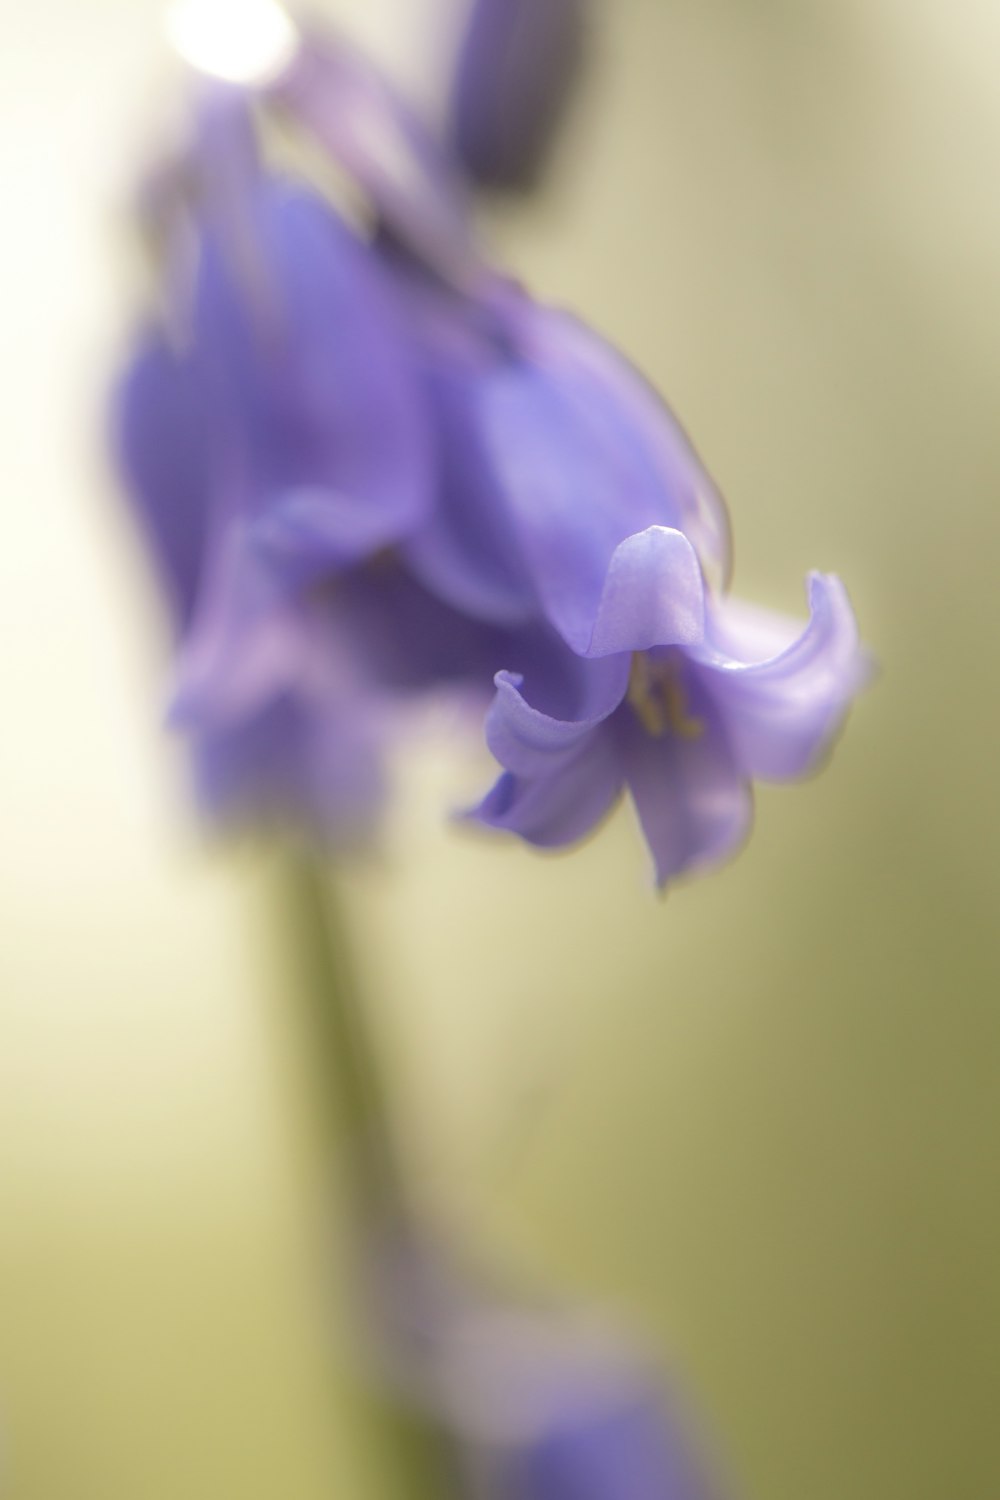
left=364, top=1233, right=721, bottom=1500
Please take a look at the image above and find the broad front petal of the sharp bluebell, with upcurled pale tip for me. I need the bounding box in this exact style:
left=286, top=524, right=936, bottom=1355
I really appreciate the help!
left=480, top=311, right=722, bottom=654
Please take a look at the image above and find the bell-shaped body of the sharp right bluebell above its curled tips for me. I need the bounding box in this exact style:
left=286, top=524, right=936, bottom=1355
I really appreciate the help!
left=383, top=270, right=730, bottom=633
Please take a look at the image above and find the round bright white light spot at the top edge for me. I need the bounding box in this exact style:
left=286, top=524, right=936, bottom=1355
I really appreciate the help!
left=165, top=0, right=298, bottom=84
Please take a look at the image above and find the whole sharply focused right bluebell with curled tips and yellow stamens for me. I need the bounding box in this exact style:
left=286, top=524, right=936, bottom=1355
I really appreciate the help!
left=431, top=289, right=867, bottom=885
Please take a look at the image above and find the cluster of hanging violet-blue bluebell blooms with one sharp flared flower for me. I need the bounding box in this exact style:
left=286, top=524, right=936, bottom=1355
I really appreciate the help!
left=115, top=23, right=865, bottom=885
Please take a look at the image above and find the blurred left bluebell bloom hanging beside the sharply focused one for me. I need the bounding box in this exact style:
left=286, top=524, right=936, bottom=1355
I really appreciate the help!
left=114, top=90, right=496, bottom=842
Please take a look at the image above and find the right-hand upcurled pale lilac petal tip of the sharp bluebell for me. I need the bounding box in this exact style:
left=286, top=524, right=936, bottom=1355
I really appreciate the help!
left=691, top=573, right=870, bottom=782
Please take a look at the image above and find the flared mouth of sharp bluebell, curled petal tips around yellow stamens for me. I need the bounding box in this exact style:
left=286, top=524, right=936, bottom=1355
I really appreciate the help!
left=472, top=567, right=867, bottom=887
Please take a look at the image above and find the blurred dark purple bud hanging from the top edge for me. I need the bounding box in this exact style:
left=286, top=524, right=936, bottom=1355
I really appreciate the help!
left=450, top=0, right=589, bottom=191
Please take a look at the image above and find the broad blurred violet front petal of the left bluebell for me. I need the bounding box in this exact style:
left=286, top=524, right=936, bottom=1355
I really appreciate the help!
left=195, top=182, right=430, bottom=582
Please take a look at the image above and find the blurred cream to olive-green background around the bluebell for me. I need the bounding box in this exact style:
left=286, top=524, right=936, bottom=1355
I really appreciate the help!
left=0, top=0, right=1000, bottom=1500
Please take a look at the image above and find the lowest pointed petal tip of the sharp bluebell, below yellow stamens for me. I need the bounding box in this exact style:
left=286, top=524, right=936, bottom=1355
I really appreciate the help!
left=615, top=684, right=753, bottom=888
